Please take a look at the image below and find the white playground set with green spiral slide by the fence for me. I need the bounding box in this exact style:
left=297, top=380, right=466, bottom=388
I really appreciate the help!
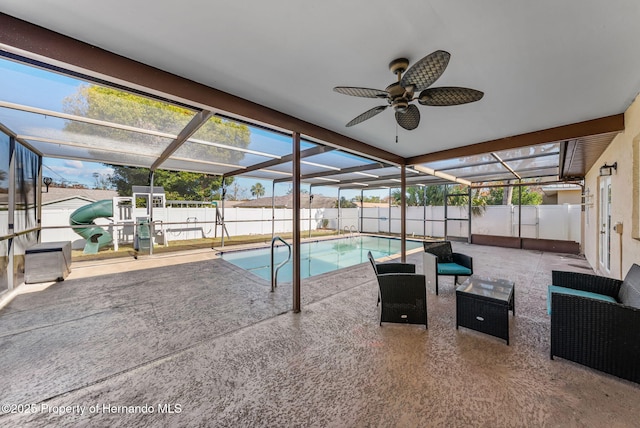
left=69, top=186, right=228, bottom=254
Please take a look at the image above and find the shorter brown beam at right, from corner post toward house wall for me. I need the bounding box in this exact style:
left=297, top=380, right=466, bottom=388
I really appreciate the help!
left=405, top=113, right=624, bottom=165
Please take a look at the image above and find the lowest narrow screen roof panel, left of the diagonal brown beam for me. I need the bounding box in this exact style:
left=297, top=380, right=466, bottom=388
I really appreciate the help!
left=26, top=140, right=156, bottom=168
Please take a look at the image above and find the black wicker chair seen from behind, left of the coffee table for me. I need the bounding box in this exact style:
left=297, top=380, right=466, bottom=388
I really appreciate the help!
left=368, top=251, right=427, bottom=328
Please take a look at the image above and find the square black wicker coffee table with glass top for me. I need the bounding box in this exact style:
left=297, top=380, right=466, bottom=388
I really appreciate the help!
left=456, top=275, right=516, bottom=345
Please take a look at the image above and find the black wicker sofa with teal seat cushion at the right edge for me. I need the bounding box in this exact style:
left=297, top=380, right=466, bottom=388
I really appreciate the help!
left=549, top=264, right=640, bottom=383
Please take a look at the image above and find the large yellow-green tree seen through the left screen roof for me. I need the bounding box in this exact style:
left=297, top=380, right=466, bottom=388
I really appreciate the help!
left=63, top=85, right=250, bottom=201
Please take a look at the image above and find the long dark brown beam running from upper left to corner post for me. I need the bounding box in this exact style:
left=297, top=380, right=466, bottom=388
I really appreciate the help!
left=0, top=13, right=404, bottom=165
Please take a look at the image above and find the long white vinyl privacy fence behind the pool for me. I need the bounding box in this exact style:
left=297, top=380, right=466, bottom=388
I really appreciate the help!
left=37, top=204, right=581, bottom=249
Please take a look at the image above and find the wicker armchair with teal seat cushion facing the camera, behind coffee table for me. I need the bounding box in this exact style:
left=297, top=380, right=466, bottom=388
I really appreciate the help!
left=422, top=241, right=473, bottom=295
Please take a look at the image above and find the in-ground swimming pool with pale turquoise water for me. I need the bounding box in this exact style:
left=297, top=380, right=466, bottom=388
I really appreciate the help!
left=220, top=236, right=422, bottom=282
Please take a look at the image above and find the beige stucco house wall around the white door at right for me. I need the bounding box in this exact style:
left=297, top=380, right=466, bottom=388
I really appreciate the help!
left=583, top=96, right=640, bottom=278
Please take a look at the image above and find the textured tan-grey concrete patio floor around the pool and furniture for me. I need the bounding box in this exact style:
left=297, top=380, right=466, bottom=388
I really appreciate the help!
left=0, top=243, right=640, bottom=427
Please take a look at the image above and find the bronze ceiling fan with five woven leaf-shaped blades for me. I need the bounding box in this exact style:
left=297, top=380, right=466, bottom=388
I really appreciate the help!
left=333, top=50, right=484, bottom=131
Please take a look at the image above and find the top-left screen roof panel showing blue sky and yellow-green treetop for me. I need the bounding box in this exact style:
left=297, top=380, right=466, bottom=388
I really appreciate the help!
left=0, top=58, right=197, bottom=135
